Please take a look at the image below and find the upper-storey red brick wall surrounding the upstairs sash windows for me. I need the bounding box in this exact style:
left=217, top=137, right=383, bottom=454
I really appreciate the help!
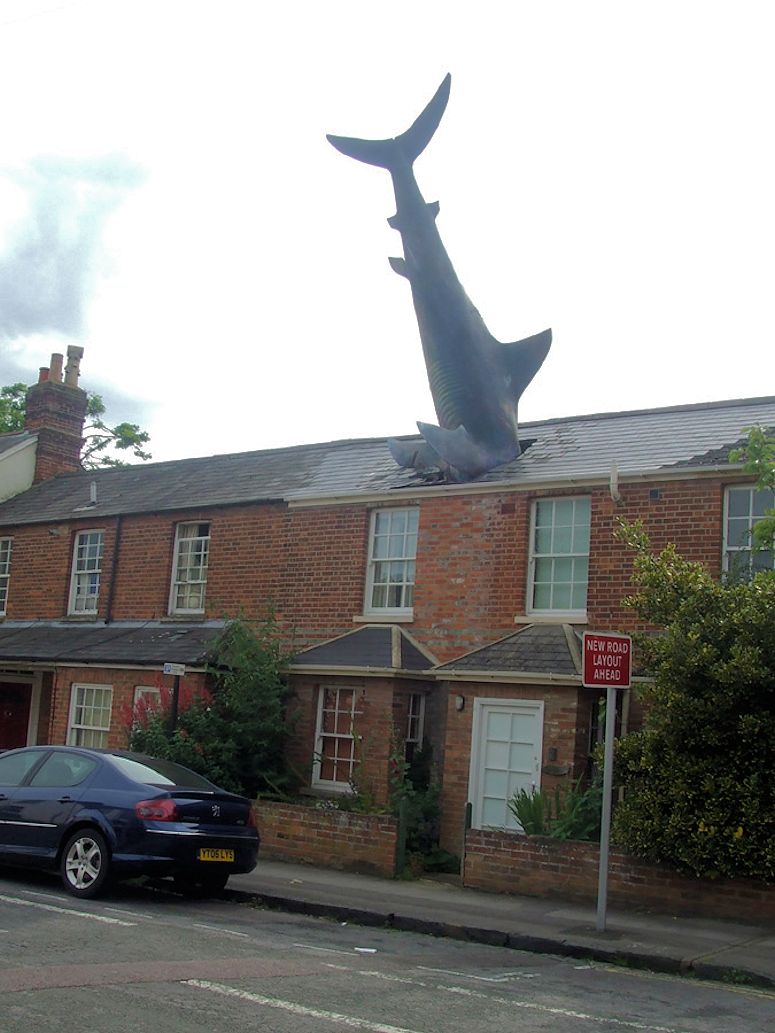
left=0, top=478, right=748, bottom=661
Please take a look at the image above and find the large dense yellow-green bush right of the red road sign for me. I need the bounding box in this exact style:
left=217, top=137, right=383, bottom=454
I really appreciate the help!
left=612, top=525, right=775, bottom=879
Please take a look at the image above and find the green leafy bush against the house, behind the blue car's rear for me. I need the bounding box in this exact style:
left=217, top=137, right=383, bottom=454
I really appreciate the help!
left=129, top=617, right=288, bottom=796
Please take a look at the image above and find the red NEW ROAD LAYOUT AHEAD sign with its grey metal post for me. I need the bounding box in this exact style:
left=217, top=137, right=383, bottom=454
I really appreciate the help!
left=582, top=631, right=632, bottom=933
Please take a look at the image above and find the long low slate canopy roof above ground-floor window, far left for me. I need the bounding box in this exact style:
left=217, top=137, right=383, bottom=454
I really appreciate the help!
left=0, top=621, right=224, bottom=667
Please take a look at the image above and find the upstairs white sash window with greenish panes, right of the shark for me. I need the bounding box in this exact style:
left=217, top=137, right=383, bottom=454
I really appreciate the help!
left=527, top=498, right=591, bottom=617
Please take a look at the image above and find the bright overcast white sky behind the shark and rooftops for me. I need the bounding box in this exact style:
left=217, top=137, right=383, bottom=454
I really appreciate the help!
left=0, top=0, right=775, bottom=460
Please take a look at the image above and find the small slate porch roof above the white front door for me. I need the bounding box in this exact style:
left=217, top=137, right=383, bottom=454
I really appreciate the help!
left=434, top=624, right=581, bottom=678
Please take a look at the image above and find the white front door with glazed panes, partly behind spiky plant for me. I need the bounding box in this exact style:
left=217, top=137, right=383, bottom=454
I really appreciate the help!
left=468, top=699, right=544, bottom=828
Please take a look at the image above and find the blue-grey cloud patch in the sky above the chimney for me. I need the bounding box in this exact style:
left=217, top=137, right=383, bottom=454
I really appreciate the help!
left=0, top=155, right=144, bottom=342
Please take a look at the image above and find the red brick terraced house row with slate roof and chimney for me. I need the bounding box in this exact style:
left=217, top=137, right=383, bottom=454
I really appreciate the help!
left=0, top=355, right=775, bottom=849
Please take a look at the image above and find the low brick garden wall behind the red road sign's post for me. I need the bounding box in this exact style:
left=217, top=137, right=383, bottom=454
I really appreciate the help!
left=463, top=829, right=775, bottom=925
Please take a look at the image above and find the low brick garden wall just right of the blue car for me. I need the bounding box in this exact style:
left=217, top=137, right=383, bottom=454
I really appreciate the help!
left=256, top=800, right=398, bottom=878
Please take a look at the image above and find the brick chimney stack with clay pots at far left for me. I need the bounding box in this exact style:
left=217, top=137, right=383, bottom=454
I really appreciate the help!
left=25, top=345, right=87, bottom=483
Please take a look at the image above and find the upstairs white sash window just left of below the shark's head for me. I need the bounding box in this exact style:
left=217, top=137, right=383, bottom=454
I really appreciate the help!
left=366, top=508, right=420, bottom=617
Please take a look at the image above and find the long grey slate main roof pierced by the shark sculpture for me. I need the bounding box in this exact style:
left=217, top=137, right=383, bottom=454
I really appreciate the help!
left=0, top=397, right=775, bottom=525
